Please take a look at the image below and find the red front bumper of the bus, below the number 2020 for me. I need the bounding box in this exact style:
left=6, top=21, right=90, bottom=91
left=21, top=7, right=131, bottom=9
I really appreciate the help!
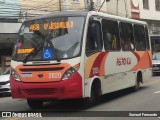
left=10, top=72, right=82, bottom=99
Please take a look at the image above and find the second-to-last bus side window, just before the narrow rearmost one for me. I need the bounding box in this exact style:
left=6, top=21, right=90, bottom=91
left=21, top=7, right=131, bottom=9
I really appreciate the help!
left=134, top=24, right=146, bottom=51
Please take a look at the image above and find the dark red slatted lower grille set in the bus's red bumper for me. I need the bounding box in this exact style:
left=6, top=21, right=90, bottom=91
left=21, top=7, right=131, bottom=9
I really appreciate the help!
left=23, top=88, right=64, bottom=95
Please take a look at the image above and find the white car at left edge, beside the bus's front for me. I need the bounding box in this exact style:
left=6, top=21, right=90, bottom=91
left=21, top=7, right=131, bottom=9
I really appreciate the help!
left=0, top=69, right=11, bottom=96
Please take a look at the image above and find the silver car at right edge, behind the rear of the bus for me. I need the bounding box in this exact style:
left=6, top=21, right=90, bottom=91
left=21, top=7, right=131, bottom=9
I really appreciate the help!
left=152, top=52, right=160, bottom=74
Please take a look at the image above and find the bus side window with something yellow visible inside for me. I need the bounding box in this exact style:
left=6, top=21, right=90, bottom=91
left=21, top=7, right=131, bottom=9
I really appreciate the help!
left=102, top=19, right=120, bottom=51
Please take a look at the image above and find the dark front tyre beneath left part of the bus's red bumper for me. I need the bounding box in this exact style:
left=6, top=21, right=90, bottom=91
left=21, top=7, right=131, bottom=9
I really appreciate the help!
left=27, top=99, right=43, bottom=109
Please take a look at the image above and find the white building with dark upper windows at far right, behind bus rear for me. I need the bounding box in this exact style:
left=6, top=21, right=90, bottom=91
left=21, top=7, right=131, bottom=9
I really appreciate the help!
left=139, top=0, right=160, bottom=52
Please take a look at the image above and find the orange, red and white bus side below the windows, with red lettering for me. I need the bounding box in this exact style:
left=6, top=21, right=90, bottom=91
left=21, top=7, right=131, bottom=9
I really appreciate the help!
left=85, top=51, right=151, bottom=94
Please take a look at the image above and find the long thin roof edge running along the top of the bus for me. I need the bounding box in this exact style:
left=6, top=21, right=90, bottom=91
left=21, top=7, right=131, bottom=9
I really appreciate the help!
left=26, top=11, right=147, bottom=25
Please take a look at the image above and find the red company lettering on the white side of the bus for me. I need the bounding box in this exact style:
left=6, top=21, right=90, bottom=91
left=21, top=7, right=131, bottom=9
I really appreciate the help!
left=116, top=57, right=131, bottom=66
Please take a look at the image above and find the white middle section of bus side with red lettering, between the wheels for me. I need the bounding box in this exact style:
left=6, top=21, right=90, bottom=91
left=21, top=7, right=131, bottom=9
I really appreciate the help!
left=103, top=51, right=137, bottom=94
